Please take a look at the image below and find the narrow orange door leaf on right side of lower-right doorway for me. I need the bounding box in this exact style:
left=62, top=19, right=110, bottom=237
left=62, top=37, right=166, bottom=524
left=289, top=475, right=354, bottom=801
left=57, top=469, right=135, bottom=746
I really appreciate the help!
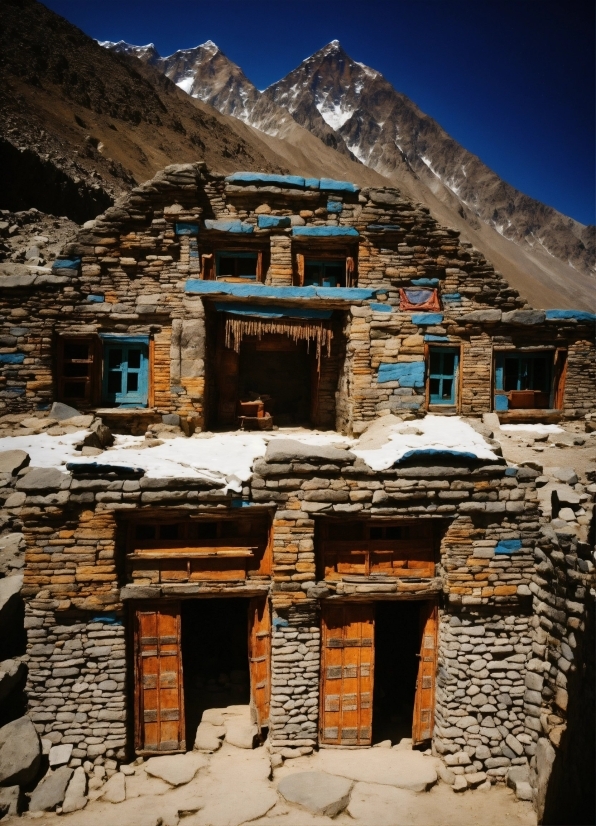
left=412, top=602, right=438, bottom=745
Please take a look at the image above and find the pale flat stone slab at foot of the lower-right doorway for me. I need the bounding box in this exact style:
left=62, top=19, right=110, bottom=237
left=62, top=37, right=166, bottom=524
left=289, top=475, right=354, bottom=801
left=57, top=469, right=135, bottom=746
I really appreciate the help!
left=317, top=749, right=437, bottom=792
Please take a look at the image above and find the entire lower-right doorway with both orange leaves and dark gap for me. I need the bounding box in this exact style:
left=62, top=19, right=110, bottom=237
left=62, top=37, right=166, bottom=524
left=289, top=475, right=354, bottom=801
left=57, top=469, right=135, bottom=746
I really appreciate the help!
left=320, top=600, right=437, bottom=747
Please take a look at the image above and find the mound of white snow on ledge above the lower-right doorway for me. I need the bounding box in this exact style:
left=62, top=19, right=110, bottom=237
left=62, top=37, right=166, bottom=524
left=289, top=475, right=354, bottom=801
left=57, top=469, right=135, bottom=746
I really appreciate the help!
left=353, top=414, right=497, bottom=470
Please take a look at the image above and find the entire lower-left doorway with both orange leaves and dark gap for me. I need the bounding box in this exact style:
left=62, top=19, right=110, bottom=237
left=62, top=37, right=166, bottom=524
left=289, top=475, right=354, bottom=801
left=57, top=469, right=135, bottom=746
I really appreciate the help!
left=134, top=595, right=271, bottom=753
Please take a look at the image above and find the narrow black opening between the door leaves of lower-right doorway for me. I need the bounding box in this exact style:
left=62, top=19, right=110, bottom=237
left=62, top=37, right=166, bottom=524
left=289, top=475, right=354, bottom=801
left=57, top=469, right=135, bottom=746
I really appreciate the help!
left=373, top=602, right=420, bottom=745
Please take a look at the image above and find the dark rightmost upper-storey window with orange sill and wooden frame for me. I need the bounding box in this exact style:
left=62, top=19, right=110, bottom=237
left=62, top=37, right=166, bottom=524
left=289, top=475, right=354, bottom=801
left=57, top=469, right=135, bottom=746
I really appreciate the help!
left=495, top=350, right=554, bottom=411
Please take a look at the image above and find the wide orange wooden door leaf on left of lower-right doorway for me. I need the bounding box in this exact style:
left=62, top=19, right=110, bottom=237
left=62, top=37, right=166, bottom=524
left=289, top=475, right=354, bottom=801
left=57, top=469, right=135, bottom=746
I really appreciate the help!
left=320, top=603, right=374, bottom=746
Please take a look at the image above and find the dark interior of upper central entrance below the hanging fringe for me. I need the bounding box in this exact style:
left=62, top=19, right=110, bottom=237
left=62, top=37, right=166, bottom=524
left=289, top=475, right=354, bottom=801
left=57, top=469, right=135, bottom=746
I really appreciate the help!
left=239, top=335, right=316, bottom=427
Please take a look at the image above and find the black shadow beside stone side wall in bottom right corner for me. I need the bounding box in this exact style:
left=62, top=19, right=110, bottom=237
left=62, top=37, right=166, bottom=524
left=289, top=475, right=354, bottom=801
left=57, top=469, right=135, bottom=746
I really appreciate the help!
left=541, top=601, right=596, bottom=826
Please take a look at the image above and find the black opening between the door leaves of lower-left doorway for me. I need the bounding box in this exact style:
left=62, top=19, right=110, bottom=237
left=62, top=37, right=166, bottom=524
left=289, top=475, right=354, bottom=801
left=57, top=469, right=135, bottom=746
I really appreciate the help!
left=182, top=599, right=250, bottom=750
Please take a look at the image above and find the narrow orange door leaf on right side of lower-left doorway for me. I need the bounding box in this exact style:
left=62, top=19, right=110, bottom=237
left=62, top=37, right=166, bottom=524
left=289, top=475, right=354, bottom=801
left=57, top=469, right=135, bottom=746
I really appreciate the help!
left=248, top=596, right=271, bottom=728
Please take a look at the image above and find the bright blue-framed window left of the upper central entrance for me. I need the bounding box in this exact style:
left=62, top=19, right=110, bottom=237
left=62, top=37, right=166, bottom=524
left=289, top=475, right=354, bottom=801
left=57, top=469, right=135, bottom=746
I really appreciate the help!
left=102, top=335, right=149, bottom=407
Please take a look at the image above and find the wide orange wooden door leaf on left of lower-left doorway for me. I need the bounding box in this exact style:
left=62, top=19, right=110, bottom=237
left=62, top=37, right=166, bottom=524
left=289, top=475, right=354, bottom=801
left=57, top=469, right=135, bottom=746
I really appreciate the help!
left=135, top=602, right=186, bottom=752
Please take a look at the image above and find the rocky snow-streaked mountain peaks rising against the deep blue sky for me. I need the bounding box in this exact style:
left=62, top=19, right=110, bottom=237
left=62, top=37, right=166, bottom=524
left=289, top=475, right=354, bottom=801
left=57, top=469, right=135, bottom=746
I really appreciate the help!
left=106, top=40, right=596, bottom=308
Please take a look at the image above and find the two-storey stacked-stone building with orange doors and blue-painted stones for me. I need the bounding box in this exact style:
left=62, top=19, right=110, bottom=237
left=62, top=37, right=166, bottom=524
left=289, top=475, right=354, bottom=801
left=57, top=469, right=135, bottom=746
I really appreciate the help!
left=0, top=164, right=596, bottom=812
